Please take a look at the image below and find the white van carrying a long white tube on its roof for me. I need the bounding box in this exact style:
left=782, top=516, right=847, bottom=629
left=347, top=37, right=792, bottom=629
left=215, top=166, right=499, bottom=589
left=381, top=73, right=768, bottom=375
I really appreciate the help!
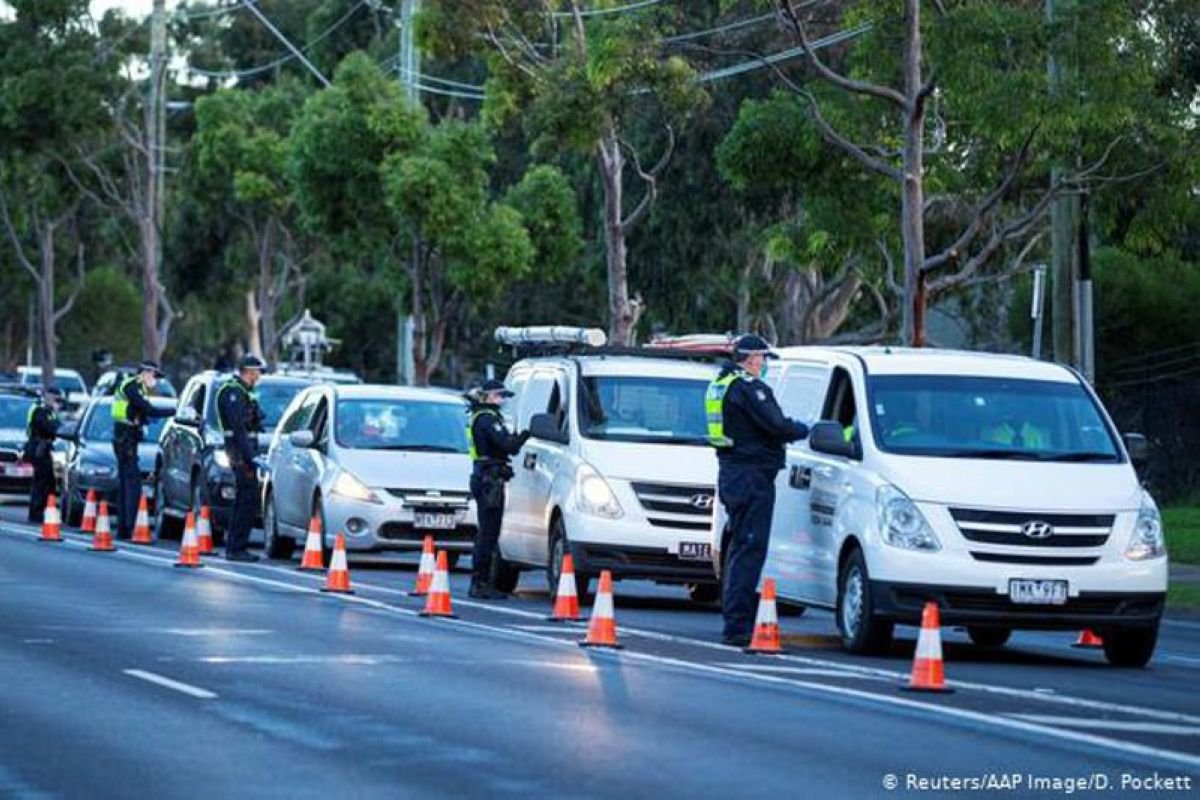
left=497, top=329, right=718, bottom=601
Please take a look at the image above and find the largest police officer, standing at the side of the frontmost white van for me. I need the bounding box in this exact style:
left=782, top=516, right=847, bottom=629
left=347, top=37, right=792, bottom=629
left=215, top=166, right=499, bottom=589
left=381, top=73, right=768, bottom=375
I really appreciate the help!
left=704, top=335, right=809, bottom=646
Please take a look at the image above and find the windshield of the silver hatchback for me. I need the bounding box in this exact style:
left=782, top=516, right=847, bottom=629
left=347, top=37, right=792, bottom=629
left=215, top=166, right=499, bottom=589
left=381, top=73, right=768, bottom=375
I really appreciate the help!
left=336, top=398, right=467, bottom=453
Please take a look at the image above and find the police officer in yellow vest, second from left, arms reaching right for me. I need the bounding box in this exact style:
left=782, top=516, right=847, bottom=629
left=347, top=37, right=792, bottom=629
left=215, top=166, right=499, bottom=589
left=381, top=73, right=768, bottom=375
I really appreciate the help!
left=113, top=361, right=174, bottom=539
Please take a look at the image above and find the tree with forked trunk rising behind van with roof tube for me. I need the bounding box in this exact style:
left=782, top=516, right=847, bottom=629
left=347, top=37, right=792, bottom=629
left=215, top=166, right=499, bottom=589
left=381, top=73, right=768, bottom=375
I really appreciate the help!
left=419, top=0, right=707, bottom=344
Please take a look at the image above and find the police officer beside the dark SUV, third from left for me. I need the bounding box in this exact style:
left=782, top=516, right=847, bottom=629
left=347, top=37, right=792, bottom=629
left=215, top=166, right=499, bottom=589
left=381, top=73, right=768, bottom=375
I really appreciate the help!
left=217, top=355, right=266, bottom=563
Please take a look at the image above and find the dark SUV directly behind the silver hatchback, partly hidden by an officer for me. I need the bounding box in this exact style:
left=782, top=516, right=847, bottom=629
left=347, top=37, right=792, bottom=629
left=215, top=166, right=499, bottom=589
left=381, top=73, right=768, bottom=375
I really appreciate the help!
left=155, top=371, right=313, bottom=541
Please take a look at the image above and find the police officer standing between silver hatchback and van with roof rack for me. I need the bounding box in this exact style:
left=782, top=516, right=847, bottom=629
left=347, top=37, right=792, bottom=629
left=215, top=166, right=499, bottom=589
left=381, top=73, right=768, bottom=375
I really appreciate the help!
left=467, top=380, right=529, bottom=600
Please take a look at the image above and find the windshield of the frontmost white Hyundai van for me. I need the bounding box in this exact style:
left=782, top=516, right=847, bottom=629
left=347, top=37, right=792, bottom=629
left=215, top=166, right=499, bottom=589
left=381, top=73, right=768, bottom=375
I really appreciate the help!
left=869, top=375, right=1121, bottom=463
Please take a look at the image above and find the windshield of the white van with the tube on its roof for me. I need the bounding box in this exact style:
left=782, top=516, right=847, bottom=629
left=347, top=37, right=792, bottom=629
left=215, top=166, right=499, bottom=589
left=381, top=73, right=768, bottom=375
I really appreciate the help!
left=580, top=375, right=708, bottom=445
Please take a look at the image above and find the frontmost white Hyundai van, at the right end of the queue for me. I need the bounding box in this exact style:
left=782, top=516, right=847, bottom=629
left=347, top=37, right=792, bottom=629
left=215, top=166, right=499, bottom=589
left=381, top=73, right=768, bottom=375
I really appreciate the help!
left=713, top=347, right=1168, bottom=666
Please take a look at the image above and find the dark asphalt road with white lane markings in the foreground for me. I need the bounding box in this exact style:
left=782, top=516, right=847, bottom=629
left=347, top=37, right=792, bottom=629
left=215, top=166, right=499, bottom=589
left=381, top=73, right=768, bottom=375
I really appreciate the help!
left=0, top=507, right=1200, bottom=798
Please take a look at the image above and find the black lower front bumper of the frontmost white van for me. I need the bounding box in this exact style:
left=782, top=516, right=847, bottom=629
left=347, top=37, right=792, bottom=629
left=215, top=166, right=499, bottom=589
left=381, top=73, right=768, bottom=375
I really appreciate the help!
left=871, top=581, right=1166, bottom=631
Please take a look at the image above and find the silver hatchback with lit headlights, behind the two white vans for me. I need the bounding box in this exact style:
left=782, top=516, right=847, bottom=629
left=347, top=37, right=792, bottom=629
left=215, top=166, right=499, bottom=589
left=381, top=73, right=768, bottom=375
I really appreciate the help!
left=263, top=384, right=475, bottom=561
